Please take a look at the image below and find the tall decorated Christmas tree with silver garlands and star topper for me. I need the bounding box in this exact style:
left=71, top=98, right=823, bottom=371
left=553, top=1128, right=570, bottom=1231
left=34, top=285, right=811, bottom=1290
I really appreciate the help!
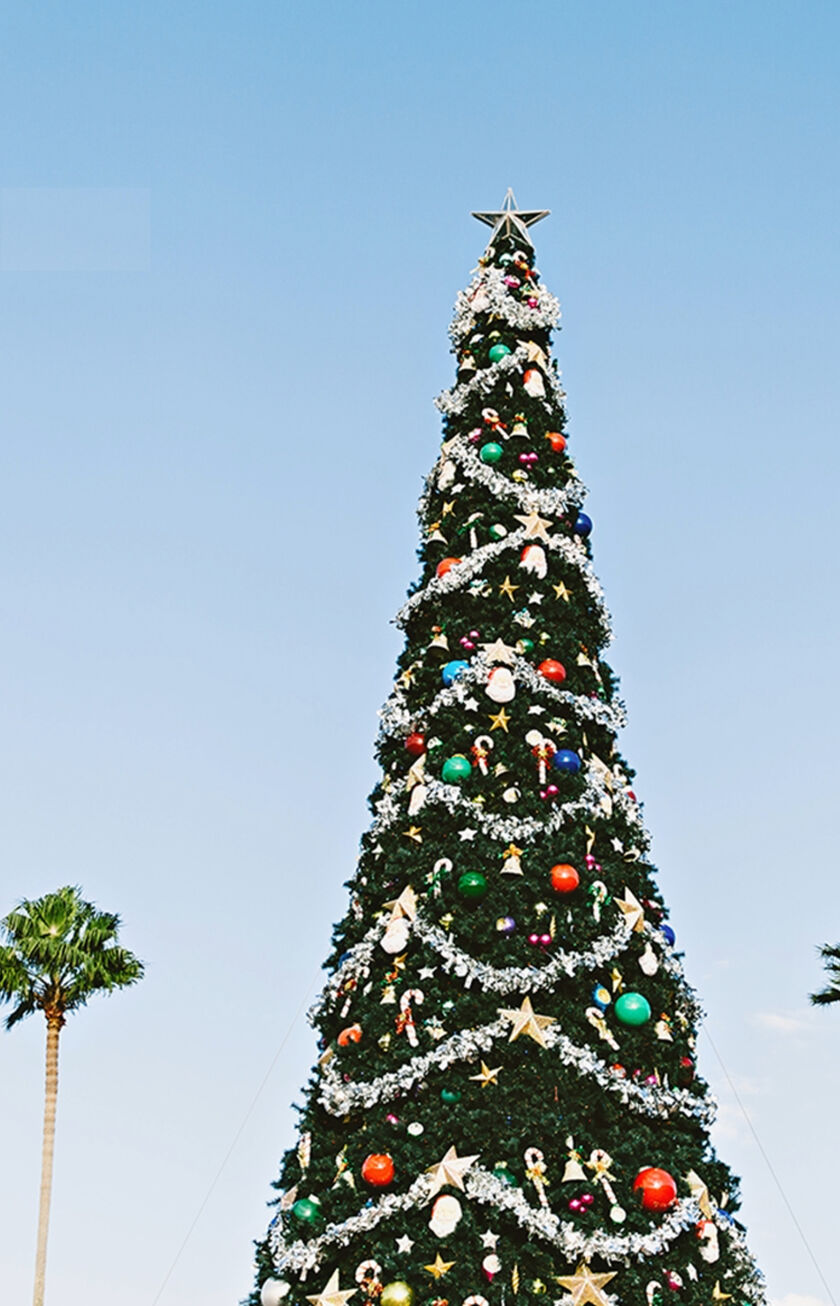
left=250, top=192, right=764, bottom=1306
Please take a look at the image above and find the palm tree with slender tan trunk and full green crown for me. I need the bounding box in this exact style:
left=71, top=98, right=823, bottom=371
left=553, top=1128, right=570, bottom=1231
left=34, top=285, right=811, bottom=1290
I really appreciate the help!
left=0, top=885, right=142, bottom=1306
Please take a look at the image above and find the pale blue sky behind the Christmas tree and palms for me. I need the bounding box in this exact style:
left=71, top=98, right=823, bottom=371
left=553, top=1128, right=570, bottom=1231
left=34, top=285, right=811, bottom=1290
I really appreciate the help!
left=0, top=0, right=840, bottom=1306
